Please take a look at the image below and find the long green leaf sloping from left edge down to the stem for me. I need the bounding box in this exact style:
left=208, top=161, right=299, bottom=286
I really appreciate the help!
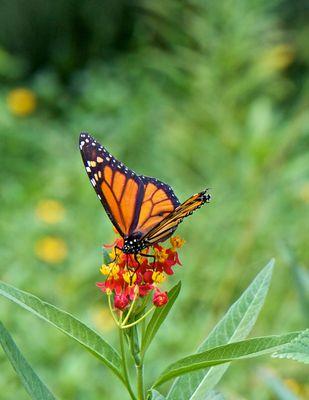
left=0, top=281, right=123, bottom=381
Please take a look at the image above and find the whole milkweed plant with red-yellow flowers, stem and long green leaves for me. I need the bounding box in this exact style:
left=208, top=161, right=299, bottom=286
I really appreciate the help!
left=0, top=236, right=309, bottom=400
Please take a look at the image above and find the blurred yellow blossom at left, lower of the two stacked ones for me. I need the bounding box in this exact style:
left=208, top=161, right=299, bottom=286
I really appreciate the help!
left=35, top=236, right=68, bottom=264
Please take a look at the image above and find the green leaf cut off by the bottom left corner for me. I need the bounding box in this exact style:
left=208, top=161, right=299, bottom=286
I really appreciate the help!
left=0, top=322, right=56, bottom=400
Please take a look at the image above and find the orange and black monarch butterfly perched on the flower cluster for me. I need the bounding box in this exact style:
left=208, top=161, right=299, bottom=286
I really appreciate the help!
left=79, top=133, right=211, bottom=254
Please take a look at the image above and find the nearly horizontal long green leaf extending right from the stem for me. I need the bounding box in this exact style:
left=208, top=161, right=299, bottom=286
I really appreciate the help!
left=153, top=332, right=300, bottom=387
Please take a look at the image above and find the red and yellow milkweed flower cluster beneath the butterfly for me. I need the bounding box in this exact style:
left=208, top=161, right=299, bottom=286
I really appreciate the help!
left=97, top=231, right=184, bottom=310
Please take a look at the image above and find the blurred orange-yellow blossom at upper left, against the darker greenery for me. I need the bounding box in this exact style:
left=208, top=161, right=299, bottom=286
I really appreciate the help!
left=7, top=88, right=37, bottom=117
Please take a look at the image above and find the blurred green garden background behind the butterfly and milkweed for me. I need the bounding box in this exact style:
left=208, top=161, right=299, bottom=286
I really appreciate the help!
left=0, top=0, right=309, bottom=400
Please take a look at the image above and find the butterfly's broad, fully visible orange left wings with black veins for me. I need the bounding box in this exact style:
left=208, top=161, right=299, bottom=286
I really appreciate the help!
left=79, top=133, right=180, bottom=237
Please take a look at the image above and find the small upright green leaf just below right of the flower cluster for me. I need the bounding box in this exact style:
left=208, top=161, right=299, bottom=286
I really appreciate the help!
left=141, top=282, right=181, bottom=355
